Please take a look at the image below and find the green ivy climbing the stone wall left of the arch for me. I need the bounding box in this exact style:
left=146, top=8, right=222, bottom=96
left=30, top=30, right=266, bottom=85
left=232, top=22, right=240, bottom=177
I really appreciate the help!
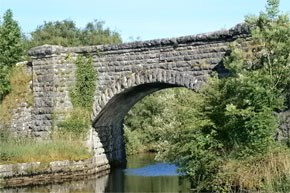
left=57, top=56, right=97, bottom=138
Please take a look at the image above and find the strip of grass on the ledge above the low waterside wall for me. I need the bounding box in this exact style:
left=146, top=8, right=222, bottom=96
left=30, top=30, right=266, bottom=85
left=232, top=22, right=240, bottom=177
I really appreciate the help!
left=0, top=131, right=91, bottom=164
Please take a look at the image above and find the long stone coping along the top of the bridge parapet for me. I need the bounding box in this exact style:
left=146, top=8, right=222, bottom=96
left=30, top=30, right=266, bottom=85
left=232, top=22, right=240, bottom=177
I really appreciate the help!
left=28, top=24, right=250, bottom=57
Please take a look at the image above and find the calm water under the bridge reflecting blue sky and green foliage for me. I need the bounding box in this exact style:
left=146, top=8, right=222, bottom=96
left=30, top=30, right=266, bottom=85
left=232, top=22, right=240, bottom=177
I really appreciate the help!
left=0, top=154, right=189, bottom=193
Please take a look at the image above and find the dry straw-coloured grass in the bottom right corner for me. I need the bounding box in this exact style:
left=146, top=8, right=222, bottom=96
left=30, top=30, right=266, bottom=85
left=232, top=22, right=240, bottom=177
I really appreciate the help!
left=213, top=148, right=290, bottom=192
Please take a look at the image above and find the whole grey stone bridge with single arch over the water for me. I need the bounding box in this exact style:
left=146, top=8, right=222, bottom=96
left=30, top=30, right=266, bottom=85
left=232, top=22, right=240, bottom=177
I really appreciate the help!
left=29, top=25, right=249, bottom=167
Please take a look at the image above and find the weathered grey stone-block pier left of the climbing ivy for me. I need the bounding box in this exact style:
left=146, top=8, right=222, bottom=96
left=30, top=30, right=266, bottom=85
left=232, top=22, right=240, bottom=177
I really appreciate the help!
left=32, top=54, right=75, bottom=137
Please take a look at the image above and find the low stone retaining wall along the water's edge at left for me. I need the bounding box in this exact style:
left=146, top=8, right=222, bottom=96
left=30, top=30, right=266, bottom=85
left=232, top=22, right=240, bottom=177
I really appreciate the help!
left=0, top=155, right=110, bottom=188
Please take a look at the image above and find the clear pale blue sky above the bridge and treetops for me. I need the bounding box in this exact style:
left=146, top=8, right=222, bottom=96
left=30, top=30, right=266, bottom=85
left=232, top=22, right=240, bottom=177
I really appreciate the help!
left=0, top=0, right=290, bottom=41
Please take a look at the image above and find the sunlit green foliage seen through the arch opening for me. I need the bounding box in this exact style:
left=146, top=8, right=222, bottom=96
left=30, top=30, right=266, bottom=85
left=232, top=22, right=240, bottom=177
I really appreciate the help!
left=125, top=88, right=201, bottom=154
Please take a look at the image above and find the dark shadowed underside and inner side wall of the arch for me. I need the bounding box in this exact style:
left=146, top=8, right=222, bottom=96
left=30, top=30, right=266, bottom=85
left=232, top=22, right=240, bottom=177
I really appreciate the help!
left=93, top=86, right=198, bottom=166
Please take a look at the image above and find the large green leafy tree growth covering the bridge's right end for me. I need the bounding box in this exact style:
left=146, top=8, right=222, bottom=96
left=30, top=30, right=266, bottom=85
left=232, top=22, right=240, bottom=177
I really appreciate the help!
left=156, top=0, right=290, bottom=192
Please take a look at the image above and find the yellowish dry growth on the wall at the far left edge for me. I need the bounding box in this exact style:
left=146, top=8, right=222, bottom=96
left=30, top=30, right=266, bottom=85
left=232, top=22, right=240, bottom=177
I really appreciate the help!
left=0, top=65, right=33, bottom=124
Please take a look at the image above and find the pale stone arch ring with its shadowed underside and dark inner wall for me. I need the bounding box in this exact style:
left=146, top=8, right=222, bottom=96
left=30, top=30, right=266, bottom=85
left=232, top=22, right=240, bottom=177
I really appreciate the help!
left=92, top=69, right=205, bottom=165
